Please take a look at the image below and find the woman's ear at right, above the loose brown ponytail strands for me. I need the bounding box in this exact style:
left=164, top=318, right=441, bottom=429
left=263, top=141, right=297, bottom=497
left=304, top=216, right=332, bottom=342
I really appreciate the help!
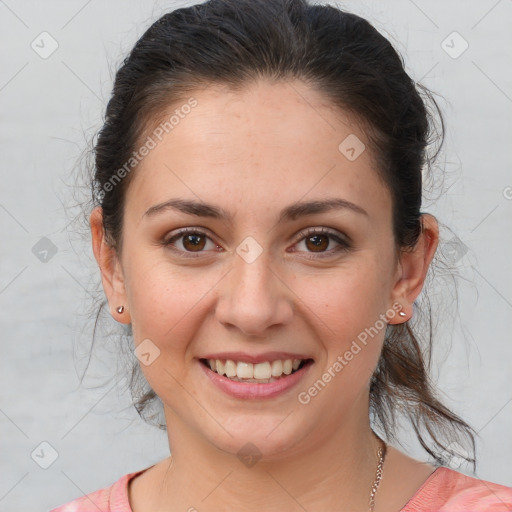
left=388, top=213, right=439, bottom=324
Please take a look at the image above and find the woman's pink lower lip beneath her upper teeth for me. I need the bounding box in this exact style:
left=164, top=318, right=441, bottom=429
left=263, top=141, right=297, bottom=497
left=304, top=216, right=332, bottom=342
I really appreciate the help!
left=198, top=361, right=313, bottom=399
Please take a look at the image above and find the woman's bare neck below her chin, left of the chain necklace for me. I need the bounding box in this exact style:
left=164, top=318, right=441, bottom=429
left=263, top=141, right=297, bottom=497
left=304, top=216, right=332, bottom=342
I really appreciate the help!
left=159, top=411, right=380, bottom=512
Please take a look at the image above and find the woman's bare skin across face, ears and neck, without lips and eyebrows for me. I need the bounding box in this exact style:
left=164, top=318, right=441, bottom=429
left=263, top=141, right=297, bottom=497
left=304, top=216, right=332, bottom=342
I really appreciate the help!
left=90, top=81, right=438, bottom=512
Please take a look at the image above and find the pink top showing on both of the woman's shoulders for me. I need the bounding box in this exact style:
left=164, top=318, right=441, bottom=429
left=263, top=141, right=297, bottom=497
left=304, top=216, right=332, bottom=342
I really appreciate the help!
left=50, top=466, right=512, bottom=512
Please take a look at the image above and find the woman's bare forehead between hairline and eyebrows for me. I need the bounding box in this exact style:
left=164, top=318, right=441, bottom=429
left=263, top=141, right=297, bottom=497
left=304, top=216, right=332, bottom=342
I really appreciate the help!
left=126, top=81, right=390, bottom=222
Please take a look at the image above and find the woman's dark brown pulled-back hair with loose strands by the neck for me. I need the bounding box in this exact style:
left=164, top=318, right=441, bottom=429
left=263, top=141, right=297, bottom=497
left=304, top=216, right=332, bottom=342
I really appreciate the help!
left=87, top=0, right=476, bottom=468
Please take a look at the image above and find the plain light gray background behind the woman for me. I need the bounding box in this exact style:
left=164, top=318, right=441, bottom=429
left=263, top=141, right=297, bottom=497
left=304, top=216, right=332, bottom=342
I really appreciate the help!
left=0, top=0, right=512, bottom=512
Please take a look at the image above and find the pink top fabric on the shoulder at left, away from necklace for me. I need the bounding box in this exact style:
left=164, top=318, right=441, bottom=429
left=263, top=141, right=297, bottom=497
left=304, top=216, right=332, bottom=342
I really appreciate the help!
left=50, top=470, right=144, bottom=512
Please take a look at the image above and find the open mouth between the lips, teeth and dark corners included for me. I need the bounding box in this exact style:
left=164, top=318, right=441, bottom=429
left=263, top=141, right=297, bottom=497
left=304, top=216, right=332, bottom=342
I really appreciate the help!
left=199, top=358, right=313, bottom=384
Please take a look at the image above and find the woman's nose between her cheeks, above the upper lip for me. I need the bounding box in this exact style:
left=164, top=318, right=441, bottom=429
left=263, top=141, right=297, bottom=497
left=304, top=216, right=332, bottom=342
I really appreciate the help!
left=216, top=247, right=294, bottom=337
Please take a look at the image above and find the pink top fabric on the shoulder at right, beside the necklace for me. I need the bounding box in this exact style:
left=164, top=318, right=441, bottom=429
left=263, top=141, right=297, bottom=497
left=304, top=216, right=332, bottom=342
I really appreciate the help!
left=401, top=466, right=512, bottom=512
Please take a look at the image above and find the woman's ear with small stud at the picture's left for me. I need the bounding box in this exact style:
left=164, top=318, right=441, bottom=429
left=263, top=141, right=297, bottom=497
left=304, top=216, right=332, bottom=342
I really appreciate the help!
left=89, top=206, right=130, bottom=324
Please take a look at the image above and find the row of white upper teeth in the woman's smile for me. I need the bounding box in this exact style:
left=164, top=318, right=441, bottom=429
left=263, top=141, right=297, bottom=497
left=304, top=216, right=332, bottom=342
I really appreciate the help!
left=208, top=359, right=302, bottom=382
